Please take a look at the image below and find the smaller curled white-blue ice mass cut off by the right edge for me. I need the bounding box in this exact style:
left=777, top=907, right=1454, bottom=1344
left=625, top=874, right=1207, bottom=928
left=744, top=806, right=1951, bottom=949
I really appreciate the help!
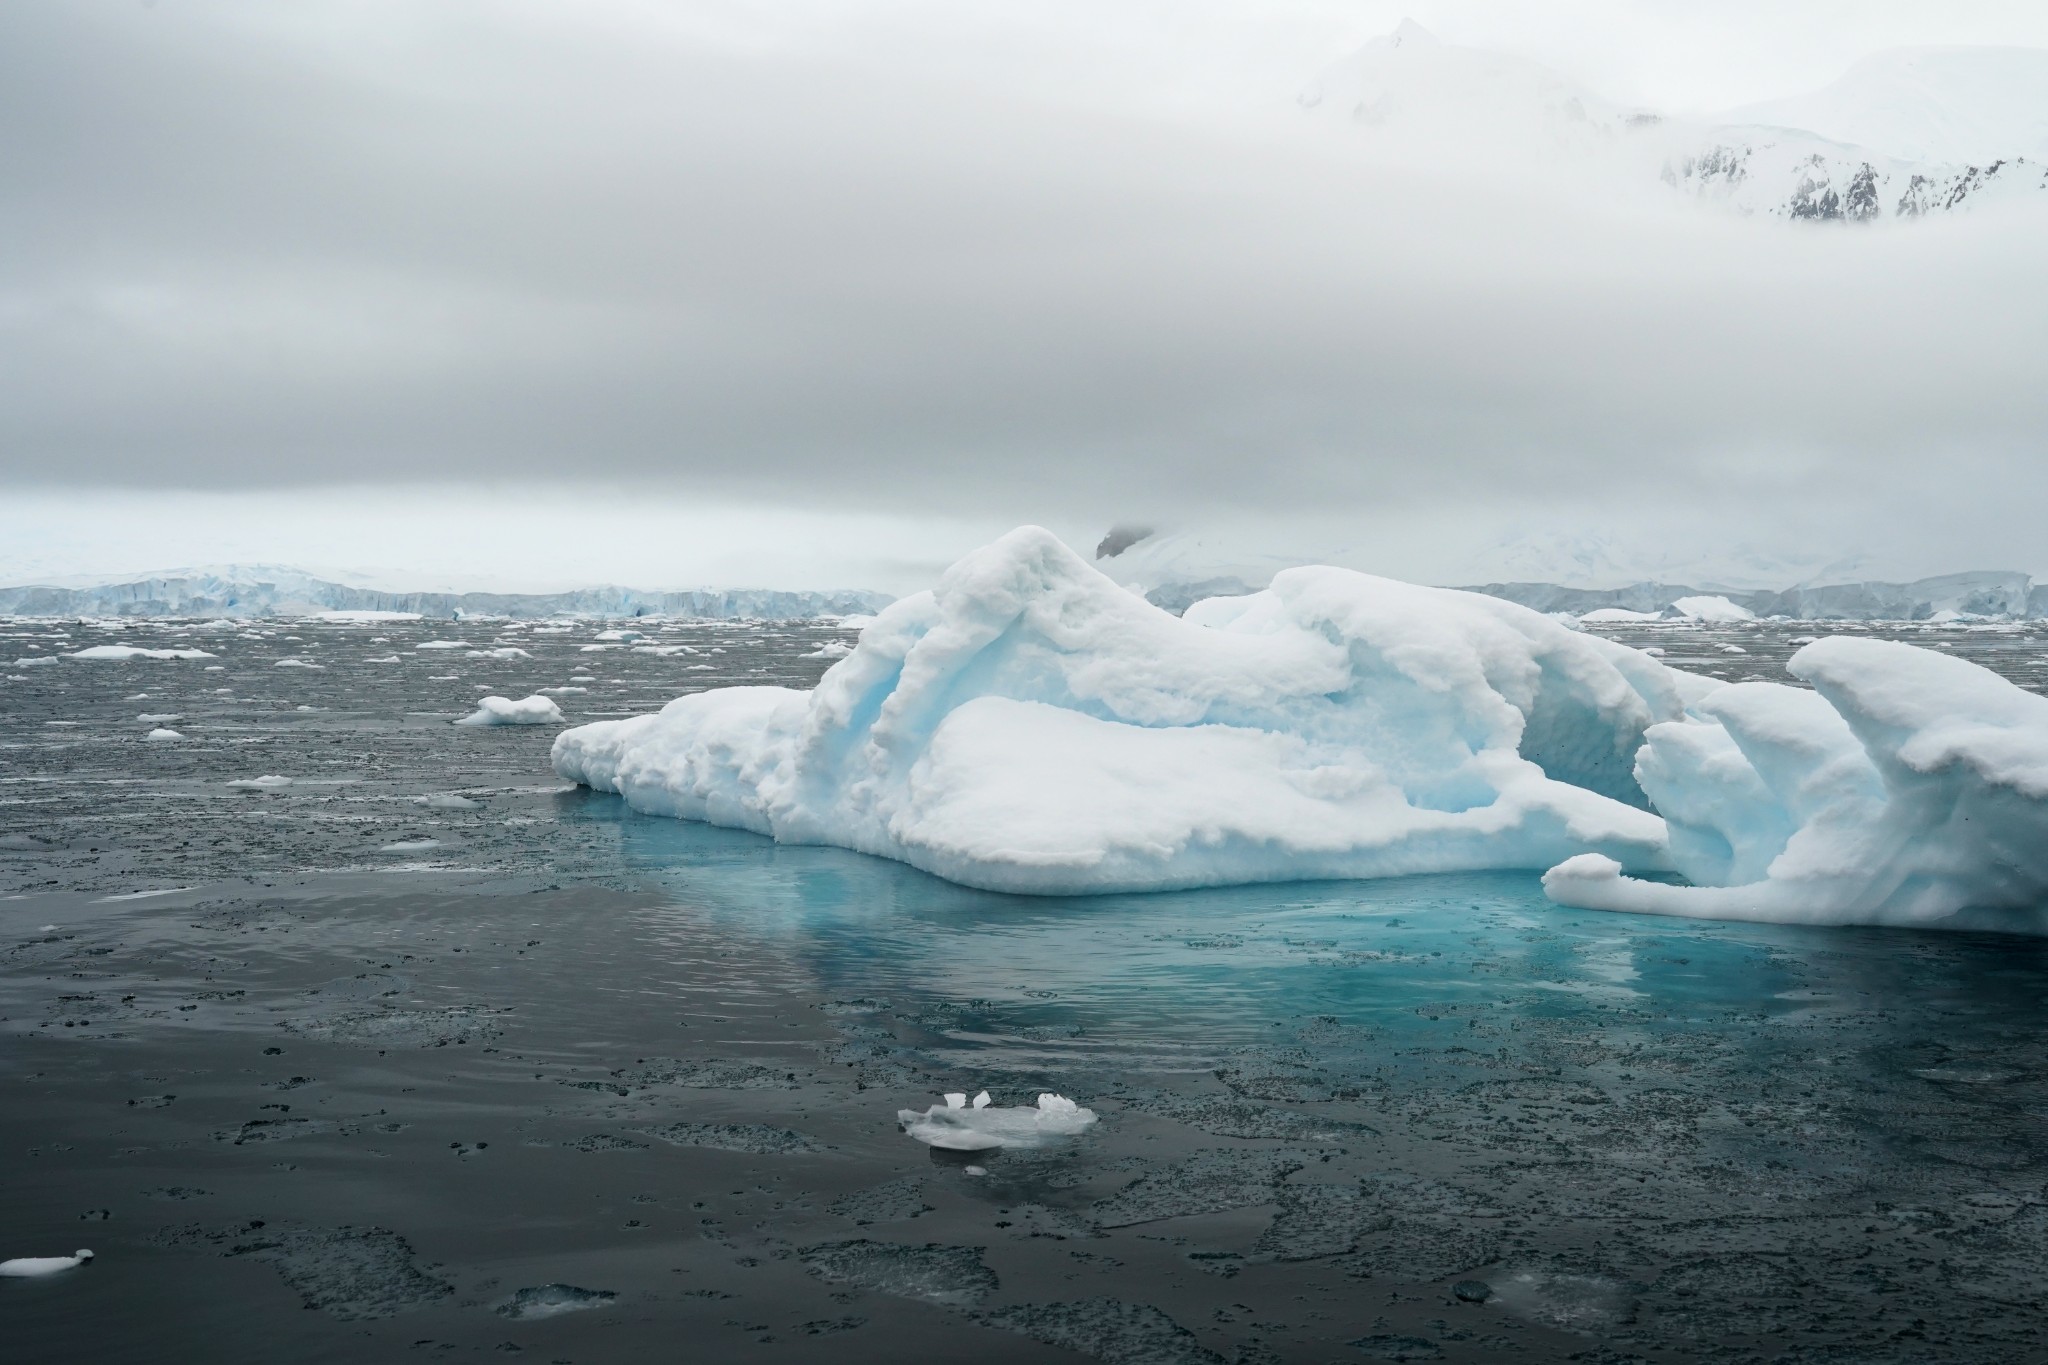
left=1544, top=639, right=2048, bottom=929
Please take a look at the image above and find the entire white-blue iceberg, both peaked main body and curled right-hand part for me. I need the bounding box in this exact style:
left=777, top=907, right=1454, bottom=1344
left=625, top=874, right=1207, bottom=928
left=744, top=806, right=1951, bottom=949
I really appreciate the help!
left=553, top=528, right=2048, bottom=927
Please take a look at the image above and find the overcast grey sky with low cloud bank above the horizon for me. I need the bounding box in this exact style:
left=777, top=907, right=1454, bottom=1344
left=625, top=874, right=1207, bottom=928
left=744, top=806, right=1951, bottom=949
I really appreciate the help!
left=0, top=0, right=2048, bottom=589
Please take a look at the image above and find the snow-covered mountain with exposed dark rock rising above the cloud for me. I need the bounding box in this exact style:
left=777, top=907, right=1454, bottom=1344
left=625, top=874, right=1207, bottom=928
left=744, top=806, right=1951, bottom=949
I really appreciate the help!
left=1298, top=20, right=2048, bottom=221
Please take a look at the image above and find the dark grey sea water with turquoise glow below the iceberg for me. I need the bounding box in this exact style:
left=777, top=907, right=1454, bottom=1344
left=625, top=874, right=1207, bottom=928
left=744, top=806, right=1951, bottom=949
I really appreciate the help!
left=0, top=622, right=2048, bottom=1365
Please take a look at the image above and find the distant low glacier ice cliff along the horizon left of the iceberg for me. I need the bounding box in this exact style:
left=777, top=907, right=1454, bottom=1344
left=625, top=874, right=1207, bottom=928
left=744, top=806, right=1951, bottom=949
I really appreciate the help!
left=0, top=565, right=893, bottom=620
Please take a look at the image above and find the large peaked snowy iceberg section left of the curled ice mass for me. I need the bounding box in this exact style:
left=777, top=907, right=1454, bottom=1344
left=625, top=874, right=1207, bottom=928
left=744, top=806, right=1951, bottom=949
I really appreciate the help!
left=553, top=528, right=1687, bottom=894
